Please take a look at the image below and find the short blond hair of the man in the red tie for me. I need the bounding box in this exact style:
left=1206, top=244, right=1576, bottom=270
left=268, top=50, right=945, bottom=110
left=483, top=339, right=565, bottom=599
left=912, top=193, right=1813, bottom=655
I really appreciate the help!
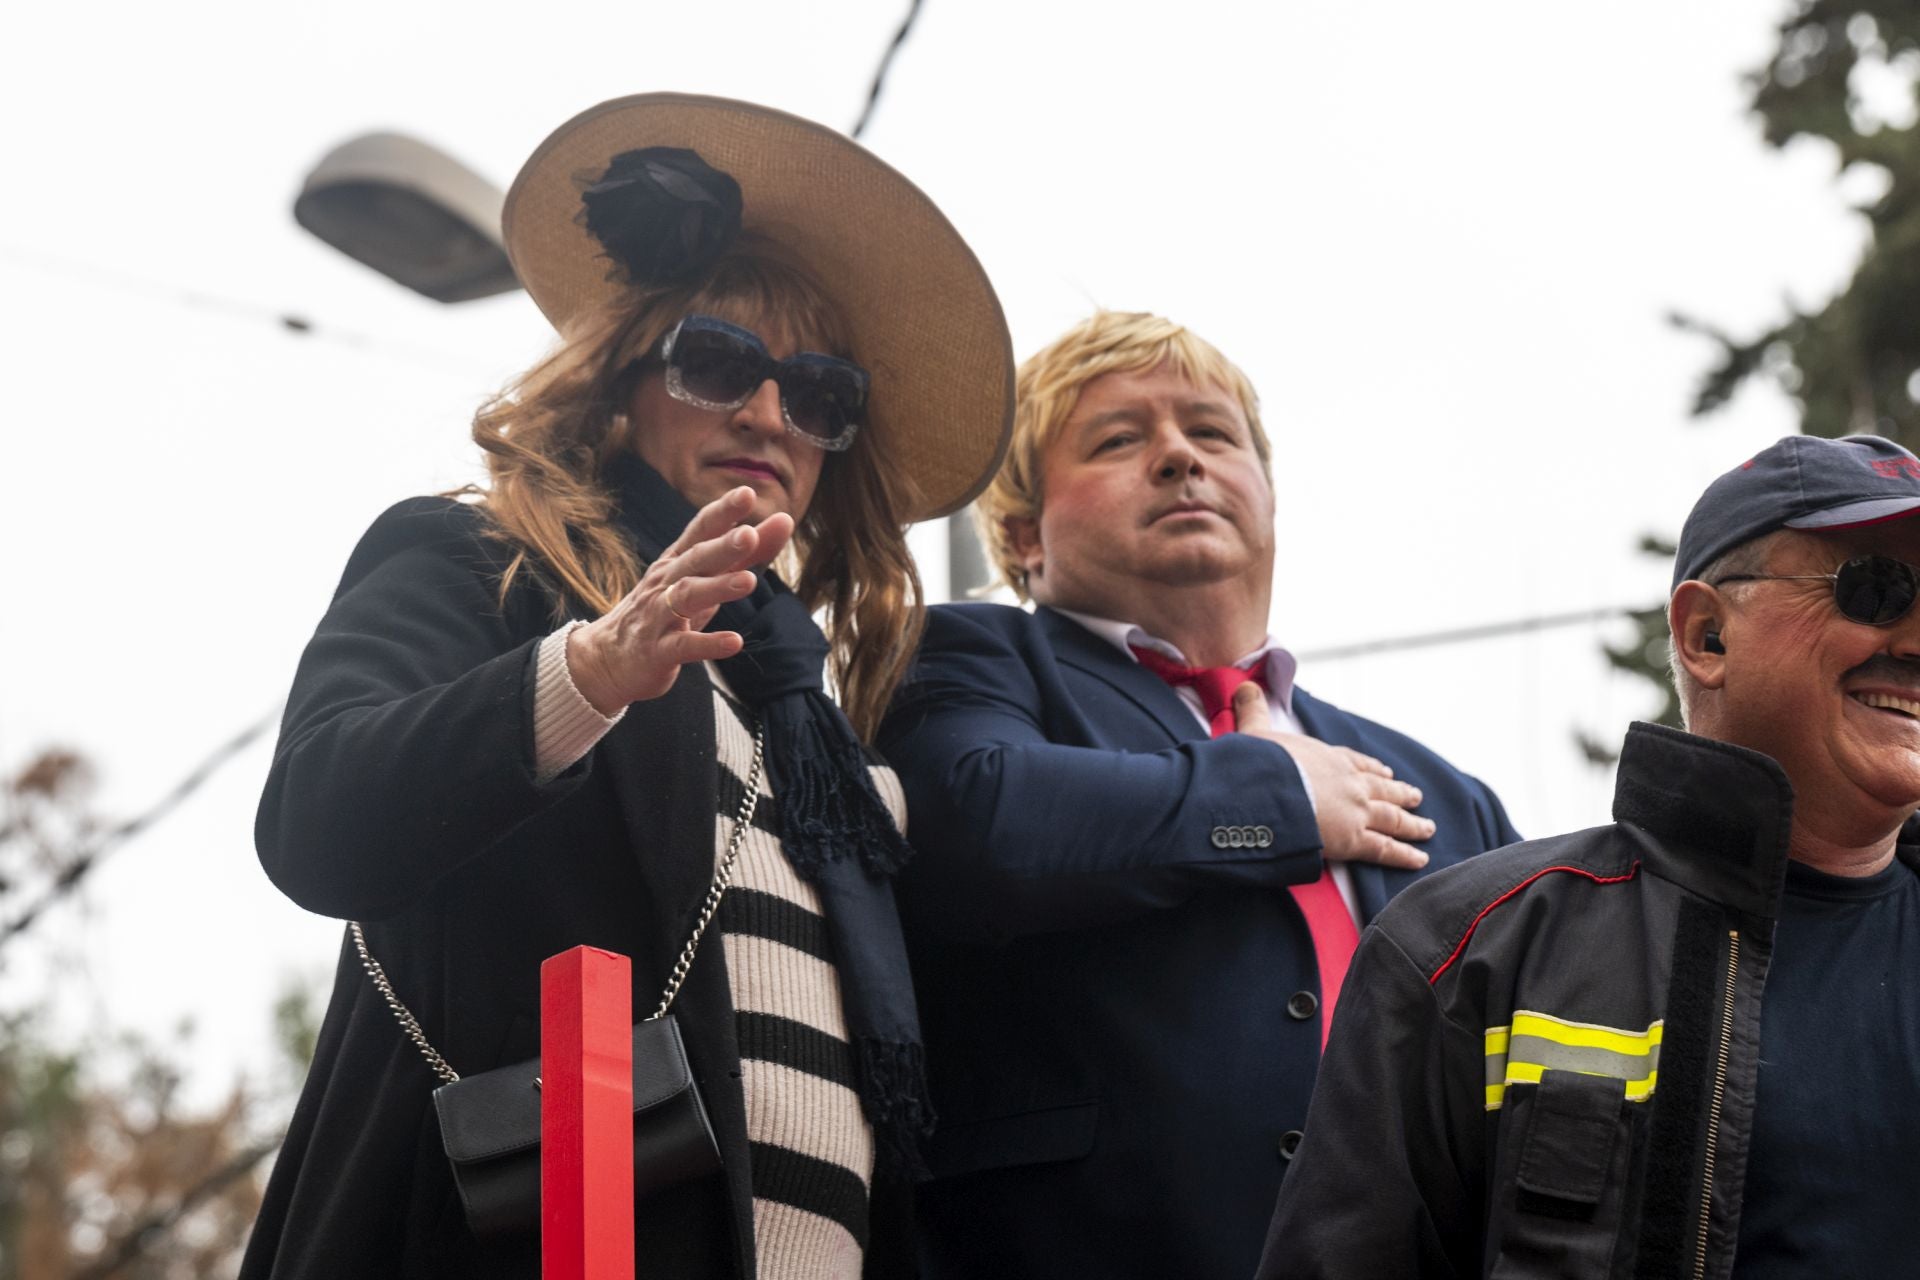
left=973, top=311, right=1273, bottom=601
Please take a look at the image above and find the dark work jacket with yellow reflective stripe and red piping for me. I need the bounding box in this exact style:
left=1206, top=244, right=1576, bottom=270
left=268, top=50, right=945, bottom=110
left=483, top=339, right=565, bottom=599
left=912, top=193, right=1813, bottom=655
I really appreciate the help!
left=1260, top=723, right=1920, bottom=1280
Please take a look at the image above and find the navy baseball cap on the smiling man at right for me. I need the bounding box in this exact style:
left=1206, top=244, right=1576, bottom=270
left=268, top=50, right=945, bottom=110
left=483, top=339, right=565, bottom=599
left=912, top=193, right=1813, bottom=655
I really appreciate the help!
left=1672, top=436, right=1920, bottom=587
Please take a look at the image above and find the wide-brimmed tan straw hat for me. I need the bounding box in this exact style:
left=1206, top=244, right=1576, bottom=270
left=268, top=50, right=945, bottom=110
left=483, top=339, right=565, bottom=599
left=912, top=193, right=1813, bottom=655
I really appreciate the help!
left=501, top=94, right=1014, bottom=520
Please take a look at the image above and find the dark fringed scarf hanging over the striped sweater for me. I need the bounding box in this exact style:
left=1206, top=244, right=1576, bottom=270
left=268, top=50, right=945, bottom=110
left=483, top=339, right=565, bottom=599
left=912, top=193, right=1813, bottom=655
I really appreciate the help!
left=607, top=455, right=933, bottom=1178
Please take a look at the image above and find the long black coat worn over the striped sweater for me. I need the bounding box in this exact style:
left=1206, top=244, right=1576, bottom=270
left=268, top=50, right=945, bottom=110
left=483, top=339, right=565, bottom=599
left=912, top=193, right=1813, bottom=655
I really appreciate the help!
left=242, top=499, right=913, bottom=1280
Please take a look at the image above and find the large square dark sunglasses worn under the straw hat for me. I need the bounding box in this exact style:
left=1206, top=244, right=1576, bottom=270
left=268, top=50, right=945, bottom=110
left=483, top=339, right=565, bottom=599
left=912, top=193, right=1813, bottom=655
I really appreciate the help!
left=660, top=315, right=872, bottom=453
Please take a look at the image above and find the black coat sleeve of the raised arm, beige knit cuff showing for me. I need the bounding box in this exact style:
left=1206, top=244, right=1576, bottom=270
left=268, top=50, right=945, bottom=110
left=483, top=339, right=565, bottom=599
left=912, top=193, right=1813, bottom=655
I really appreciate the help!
left=253, top=499, right=586, bottom=919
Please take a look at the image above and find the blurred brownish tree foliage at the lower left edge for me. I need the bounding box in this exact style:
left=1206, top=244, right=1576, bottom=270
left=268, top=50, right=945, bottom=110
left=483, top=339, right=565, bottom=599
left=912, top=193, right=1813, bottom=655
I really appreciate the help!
left=0, top=750, right=313, bottom=1280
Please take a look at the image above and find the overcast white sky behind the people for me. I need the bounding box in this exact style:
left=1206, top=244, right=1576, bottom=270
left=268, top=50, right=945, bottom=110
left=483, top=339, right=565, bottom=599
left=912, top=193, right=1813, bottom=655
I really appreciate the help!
left=0, top=0, right=1889, bottom=1113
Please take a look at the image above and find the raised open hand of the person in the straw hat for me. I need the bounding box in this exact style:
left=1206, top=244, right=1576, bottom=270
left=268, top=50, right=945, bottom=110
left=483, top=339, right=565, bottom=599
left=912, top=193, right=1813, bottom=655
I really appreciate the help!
left=566, top=486, right=793, bottom=716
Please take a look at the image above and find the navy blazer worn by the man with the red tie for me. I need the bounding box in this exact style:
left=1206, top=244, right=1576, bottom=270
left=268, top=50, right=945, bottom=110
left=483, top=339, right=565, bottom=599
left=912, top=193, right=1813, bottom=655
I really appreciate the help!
left=879, top=604, right=1519, bottom=1280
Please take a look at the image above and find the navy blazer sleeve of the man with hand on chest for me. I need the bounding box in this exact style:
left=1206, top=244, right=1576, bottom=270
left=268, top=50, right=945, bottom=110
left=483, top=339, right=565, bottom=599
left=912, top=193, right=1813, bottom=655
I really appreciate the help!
left=879, top=610, right=1321, bottom=942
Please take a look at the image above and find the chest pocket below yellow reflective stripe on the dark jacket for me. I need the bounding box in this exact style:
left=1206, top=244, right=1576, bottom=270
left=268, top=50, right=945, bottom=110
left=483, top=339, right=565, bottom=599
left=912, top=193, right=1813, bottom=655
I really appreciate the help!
left=1486, top=1071, right=1634, bottom=1280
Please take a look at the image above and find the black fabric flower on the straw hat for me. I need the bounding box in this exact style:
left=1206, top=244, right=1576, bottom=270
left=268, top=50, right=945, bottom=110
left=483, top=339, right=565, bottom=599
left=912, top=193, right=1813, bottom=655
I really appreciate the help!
left=580, top=146, right=741, bottom=286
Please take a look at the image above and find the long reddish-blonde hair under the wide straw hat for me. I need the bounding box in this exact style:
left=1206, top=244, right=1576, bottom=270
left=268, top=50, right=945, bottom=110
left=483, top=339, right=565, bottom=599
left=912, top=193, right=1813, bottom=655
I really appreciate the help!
left=468, top=236, right=925, bottom=739
